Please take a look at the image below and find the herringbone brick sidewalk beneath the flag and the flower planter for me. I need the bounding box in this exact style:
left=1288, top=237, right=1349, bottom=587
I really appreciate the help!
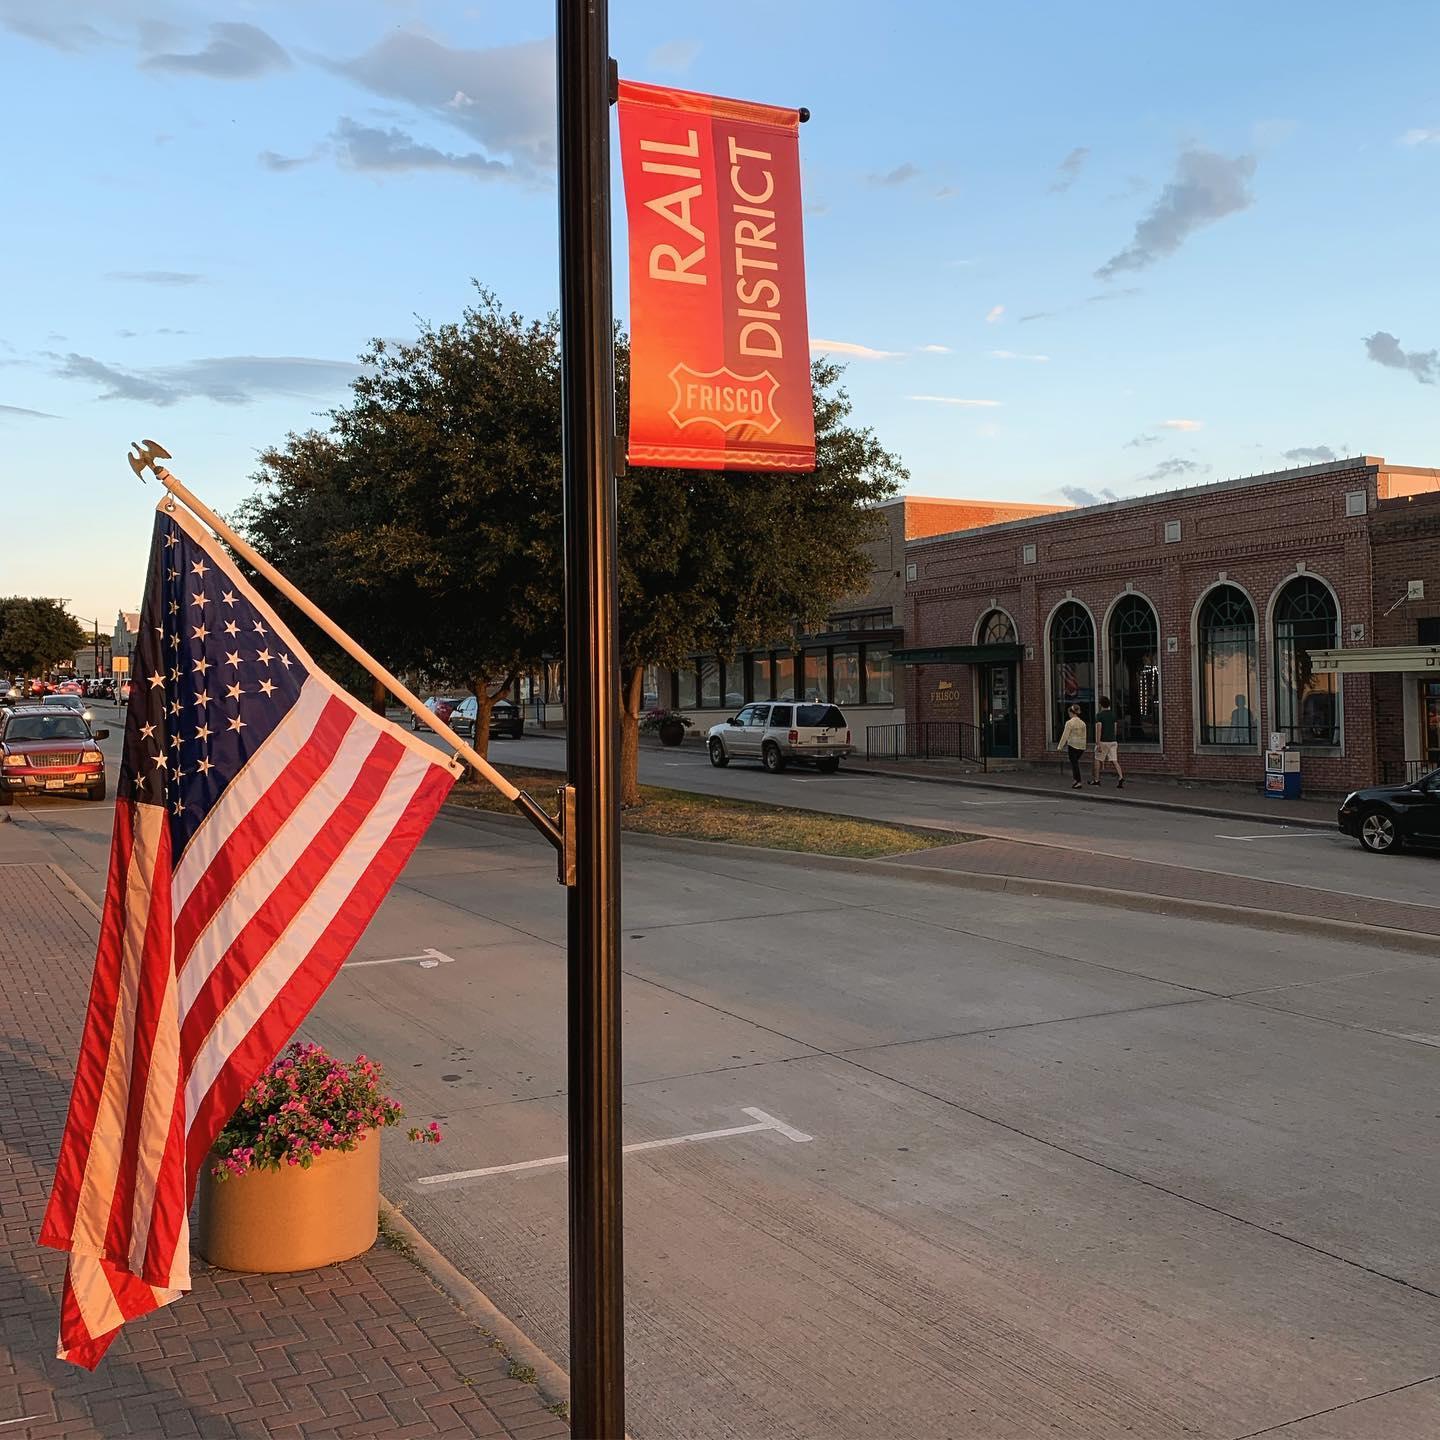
left=0, top=852, right=569, bottom=1440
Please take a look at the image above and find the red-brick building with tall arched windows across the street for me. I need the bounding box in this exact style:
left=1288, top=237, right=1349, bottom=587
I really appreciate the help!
left=894, top=456, right=1440, bottom=791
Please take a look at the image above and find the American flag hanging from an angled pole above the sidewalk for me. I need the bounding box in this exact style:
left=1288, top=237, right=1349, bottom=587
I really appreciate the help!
left=40, top=501, right=461, bottom=1368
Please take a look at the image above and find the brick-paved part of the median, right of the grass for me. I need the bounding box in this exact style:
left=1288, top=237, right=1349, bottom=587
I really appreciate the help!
left=896, top=840, right=1440, bottom=935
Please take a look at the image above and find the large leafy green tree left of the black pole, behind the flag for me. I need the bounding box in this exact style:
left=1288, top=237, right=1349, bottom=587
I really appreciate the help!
left=239, top=289, right=562, bottom=753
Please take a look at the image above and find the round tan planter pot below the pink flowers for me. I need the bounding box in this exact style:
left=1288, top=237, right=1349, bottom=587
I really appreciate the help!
left=194, top=1130, right=380, bottom=1274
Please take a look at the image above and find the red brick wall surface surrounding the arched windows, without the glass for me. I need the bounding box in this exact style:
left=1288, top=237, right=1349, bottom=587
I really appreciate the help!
left=903, top=456, right=1440, bottom=792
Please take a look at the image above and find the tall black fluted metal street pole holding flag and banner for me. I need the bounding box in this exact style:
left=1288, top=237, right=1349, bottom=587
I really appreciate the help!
left=556, top=0, right=625, bottom=1440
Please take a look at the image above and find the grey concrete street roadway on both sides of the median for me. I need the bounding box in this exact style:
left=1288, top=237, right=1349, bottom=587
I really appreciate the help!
left=14, top=760, right=1440, bottom=1440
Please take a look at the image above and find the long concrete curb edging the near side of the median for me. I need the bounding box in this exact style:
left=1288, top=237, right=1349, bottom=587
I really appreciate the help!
left=441, top=805, right=1440, bottom=955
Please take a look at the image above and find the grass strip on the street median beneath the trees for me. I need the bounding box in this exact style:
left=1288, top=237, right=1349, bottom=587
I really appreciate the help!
left=451, top=765, right=975, bottom=860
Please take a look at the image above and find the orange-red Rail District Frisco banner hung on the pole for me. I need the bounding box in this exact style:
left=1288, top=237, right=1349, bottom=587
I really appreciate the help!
left=619, top=81, right=815, bottom=471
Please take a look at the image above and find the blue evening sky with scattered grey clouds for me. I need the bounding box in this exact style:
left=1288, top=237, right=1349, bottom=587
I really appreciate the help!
left=0, top=0, right=1440, bottom=629
